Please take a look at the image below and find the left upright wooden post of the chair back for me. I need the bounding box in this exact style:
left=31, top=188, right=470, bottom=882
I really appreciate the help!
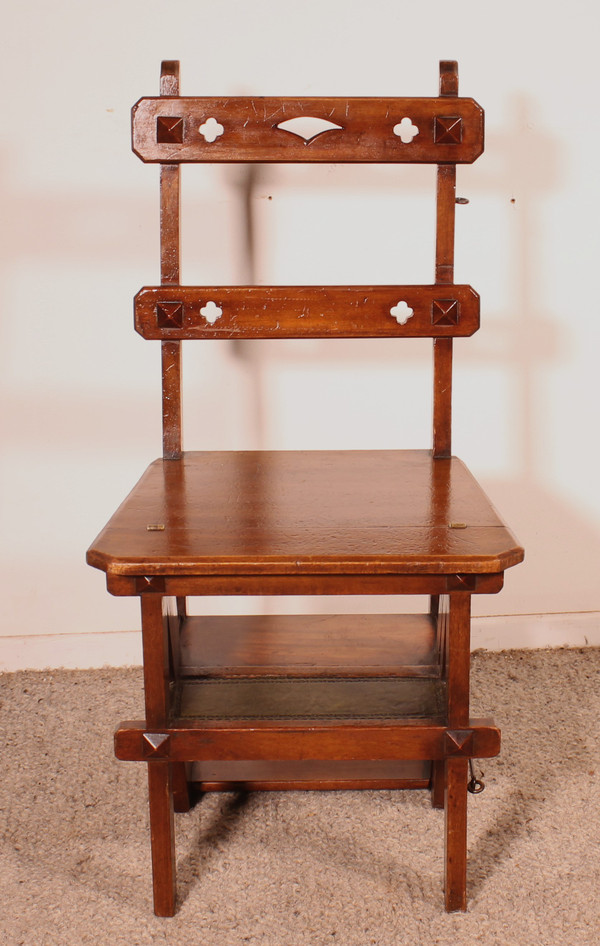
left=160, top=61, right=182, bottom=460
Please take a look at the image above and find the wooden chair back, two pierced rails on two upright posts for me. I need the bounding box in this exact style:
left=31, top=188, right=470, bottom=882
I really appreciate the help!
left=132, top=61, right=483, bottom=459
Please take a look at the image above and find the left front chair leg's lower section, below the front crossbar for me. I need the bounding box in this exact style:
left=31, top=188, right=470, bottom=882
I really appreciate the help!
left=148, top=762, right=176, bottom=916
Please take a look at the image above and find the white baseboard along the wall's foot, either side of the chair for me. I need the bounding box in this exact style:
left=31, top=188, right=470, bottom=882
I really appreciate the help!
left=0, top=611, right=600, bottom=671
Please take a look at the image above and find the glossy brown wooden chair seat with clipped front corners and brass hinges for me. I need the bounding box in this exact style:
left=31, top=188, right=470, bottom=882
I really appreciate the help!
left=88, top=450, right=523, bottom=576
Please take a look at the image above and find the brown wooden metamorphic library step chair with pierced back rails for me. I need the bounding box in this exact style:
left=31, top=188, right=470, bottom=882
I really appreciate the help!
left=88, top=62, right=523, bottom=916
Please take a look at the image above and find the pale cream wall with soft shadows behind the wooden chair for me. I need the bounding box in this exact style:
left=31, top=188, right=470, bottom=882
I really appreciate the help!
left=0, top=0, right=600, bottom=666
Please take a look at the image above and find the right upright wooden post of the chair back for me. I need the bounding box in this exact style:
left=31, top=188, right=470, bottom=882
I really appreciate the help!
left=433, top=60, right=458, bottom=457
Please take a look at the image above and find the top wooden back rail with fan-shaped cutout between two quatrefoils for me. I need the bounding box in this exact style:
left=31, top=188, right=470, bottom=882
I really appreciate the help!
left=132, top=96, right=483, bottom=164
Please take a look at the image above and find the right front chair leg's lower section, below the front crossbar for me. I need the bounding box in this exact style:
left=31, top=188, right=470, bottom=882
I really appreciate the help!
left=444, top=758, right=469, bottom=912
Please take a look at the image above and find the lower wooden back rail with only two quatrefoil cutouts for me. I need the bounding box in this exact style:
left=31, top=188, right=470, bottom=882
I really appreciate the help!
left=134, top=285, right=479, bottom=339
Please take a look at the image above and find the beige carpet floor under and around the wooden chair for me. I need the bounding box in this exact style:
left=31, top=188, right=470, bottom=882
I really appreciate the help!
left=0, top=649, right=600, bottom=946
